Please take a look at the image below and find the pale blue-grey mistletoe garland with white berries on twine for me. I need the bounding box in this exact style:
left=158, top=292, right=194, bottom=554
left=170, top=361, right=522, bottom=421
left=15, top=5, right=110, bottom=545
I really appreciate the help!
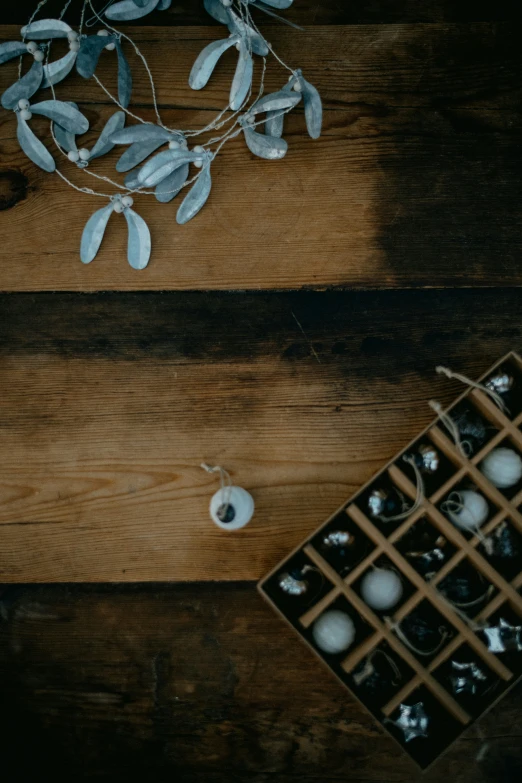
left=0, top=0, right=322, bottom=269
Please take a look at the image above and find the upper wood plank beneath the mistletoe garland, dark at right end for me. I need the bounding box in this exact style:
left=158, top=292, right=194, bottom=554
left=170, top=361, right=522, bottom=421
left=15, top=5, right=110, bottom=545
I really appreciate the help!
left=0, top=24, right=522, bottom=291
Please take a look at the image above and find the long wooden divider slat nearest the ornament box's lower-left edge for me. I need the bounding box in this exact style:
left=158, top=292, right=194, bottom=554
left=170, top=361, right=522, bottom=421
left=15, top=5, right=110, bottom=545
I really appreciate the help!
left=304, top=545, right=471, bottom=725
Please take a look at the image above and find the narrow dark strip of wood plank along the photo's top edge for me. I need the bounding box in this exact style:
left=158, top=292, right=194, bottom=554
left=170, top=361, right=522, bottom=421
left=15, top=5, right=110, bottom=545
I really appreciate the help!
left=2, top=0, right=520, bottom=26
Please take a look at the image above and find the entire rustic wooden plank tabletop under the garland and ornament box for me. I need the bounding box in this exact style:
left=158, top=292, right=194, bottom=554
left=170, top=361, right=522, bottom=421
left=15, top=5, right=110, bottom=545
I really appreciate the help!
left=0, top=0, right=522, bottom=783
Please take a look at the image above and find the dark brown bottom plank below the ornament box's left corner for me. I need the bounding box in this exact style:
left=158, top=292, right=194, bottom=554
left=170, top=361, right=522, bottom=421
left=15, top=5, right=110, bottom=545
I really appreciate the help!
left=0, top=584, right=522, bottom=783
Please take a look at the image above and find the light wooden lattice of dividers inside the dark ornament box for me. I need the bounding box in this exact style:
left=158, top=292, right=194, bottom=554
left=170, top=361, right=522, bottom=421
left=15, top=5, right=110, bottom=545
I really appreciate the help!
left=259, top=353, right=522, bottom=772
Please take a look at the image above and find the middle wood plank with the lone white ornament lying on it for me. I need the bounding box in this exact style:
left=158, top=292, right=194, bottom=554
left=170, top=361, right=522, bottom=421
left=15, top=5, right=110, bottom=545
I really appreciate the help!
left=0, top=290, right=522, bottom=582
